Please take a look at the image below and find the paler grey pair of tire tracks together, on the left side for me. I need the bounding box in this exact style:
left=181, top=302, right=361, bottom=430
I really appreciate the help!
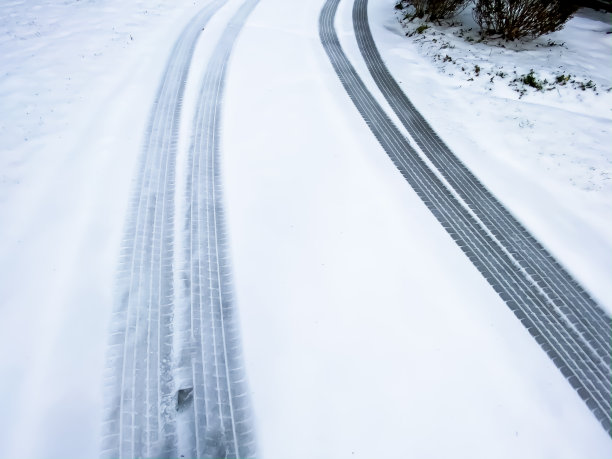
left=101, top=0, right=257, bottom=458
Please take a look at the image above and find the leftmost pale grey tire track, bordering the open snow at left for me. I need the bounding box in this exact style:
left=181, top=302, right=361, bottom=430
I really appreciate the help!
left=101, top=0, right=224, bottom=458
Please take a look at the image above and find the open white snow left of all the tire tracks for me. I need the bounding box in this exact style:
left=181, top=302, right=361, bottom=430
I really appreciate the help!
left=0, top=0, right=213, bottom=458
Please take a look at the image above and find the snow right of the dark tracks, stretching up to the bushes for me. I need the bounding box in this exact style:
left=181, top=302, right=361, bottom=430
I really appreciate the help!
left=369, top=0, right=612, bottom=312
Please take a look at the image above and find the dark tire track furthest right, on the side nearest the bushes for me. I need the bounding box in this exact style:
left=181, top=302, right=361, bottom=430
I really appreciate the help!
left=353, top=0, right=612, bottom=370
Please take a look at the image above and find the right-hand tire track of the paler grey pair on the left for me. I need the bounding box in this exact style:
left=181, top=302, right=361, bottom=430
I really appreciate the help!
left=179, top=0, right=259, bottom=458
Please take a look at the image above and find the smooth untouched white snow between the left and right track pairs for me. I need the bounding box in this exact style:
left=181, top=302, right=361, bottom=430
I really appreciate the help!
left=223, top=1, right=611, bottom=458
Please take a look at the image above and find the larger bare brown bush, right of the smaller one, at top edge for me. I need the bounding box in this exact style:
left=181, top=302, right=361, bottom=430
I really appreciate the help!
left=473, top=0, right=577, bottom=40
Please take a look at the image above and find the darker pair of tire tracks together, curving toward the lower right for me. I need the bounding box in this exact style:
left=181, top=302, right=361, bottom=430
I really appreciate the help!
left=319, top=0, right=612, bottom=435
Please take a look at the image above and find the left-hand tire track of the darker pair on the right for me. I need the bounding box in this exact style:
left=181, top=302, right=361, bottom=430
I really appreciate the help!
left=319, top=0, right=612, bottom=434
